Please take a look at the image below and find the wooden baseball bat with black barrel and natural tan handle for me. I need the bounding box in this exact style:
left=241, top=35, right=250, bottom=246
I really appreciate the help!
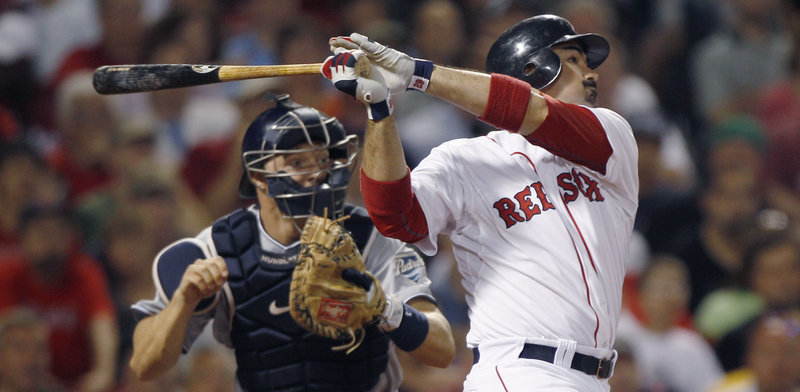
left=93, top=57, right=370, bottom=94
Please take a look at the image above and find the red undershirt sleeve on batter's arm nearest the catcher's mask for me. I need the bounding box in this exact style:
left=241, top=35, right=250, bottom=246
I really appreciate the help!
left=361, top=170, right=428, bottom=243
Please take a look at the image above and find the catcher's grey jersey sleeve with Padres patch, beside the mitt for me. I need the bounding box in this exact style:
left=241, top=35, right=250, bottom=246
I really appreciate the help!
left=363, top=230, right=436, bottom=303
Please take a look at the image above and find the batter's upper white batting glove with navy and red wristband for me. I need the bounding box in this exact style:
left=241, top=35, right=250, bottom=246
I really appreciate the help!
left=328, top=33, right=433, bottom=95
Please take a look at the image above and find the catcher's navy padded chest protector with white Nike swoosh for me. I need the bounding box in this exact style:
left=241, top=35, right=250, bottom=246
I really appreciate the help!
left=212, top=210, right=389, bottom=392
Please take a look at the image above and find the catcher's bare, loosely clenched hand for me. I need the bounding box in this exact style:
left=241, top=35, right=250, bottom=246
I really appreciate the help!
left=176, top=256, right=228, bottom=303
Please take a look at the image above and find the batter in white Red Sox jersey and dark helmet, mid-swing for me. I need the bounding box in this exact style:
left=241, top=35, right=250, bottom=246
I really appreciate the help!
left=323, top=15, right=638, bottom=392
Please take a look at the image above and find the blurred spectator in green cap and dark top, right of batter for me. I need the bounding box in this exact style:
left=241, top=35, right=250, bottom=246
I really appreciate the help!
left=674, top=116, right=788, bottom=312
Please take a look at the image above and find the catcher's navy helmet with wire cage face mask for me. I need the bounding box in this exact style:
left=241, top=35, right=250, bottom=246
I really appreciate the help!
left=239, top=95, right=358, bottom=218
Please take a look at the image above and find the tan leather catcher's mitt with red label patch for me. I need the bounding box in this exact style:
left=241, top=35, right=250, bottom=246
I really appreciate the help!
left=289, top=216, right=386, bottom=354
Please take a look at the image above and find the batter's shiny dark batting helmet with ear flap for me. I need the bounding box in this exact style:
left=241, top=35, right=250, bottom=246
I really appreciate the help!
left=486, top=15, right=610, bottom=89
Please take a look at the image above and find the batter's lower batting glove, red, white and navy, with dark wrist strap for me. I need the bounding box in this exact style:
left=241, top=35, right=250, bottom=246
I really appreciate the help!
left=321, top=50, right=394, bottom=121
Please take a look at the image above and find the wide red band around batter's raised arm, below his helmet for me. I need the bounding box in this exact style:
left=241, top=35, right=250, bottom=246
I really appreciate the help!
left=478, top=73, right=531, bottom=132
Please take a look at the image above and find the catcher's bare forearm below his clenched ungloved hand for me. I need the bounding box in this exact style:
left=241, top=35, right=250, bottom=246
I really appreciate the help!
left=130, top=295, right=197, bottom=380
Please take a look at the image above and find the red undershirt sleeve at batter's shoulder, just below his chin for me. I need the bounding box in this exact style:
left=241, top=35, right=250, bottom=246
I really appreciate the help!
left=527, top=94, right=614, bottom=175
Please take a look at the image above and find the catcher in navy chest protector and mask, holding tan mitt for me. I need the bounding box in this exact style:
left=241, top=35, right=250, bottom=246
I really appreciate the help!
left=130, top=95, right=455, bottom=392
